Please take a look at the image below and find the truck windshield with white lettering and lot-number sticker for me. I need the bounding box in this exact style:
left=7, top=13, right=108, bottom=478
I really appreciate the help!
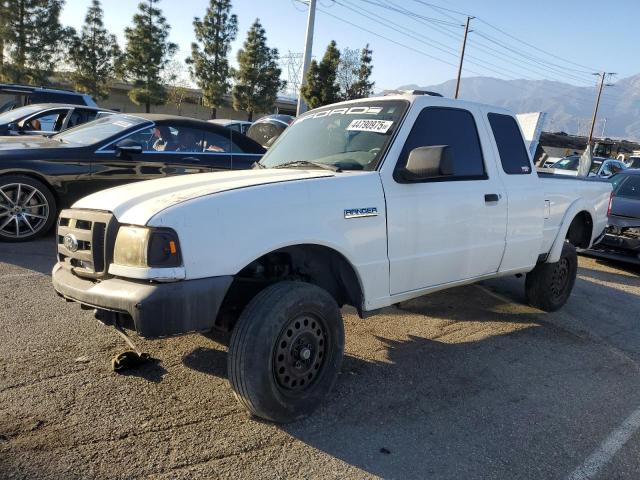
left=260, top=100, right=409, bottom=170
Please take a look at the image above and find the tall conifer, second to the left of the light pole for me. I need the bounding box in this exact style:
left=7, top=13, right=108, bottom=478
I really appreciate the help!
left=187, top=0, right=238, bottom=118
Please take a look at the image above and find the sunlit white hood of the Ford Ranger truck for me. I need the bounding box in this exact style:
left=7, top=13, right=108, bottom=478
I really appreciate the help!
left=73, top=169, right=335, bottom=225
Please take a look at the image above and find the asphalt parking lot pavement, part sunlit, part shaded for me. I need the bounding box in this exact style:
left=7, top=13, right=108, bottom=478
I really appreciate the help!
left=0, top=237, right=640, bottom=480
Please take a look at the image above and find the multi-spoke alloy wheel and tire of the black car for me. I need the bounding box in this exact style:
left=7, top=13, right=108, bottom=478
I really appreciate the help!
left=0, top=175, right=57, bottom=242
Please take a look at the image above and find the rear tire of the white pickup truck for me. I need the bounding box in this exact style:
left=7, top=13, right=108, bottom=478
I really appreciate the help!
left=525, top=242, right=578, bottom=312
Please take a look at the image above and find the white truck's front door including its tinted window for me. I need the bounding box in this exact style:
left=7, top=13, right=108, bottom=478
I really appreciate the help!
left=385, top=107, right=507, bottom=295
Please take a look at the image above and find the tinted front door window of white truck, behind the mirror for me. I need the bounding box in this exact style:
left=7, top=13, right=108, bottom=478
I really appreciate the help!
left=396, top=107, right=488, bottom=182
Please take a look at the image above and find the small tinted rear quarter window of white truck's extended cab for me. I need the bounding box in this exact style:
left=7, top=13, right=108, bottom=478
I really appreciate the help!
left=488, top=113, right=531, bottom=175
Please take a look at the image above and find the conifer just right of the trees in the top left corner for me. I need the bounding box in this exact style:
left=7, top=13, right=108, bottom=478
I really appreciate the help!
left=69, top=0, right=120, bottom=99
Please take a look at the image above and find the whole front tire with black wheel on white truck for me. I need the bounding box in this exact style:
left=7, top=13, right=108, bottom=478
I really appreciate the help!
left=228, top=281, right=344, bottom=423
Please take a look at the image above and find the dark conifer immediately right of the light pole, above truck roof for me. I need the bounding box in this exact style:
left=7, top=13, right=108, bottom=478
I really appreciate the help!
left=300, top=40, right=341, bottom=108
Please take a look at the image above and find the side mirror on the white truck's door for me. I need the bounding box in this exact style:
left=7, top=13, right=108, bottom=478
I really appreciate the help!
left=399, top=145, right=454, bottom=182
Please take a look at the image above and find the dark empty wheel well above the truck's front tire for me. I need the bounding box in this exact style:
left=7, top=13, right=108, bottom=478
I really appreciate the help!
left=216, top=245, right=363, bottom=330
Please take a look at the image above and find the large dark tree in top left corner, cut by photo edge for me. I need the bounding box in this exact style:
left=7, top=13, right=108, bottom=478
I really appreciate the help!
left=0, top=0, right=70, bottom=84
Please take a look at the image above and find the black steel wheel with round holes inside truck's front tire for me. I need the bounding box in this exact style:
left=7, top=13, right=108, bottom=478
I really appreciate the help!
left=273, top=315, right=327, bottom=393
